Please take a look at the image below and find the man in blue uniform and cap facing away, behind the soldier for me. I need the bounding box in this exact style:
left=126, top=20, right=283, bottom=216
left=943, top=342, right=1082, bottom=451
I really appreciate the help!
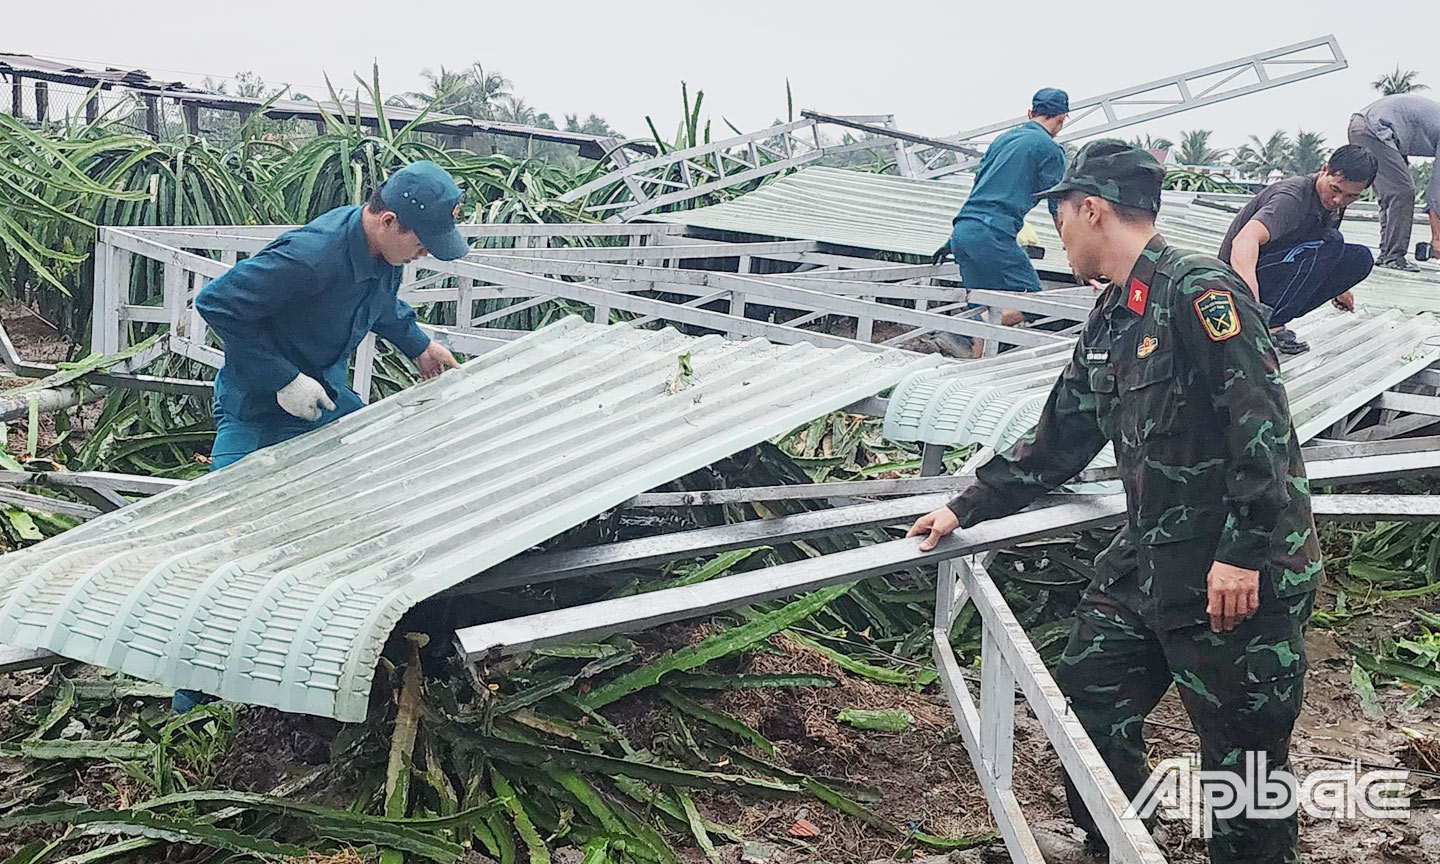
left=933, top=86, right=1070, bottom=357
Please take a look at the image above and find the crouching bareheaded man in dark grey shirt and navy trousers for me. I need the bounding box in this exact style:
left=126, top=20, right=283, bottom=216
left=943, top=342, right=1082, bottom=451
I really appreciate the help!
left=1220, top=144, right=1377, bottom=354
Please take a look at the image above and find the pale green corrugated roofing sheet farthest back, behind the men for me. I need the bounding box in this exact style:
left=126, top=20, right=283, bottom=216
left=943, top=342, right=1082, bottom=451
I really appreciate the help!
left=644, top=167, right=1440, bottom=312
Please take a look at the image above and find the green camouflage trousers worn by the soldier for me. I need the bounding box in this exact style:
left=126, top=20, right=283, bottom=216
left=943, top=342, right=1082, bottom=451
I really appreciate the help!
left=1056, top=570, right=1315, bottom=864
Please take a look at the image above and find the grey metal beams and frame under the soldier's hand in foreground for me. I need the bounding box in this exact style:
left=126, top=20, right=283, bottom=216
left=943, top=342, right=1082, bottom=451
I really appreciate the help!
left=452, top=439, right=1440, bottom=864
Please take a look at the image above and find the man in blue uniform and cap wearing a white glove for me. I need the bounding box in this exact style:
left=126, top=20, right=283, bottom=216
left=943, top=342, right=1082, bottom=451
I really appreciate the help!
left=194, top=161, right=469, bottom=471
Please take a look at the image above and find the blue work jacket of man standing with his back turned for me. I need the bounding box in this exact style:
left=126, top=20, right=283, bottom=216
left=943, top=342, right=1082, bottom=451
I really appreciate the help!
left=955, top=120, right=1066, bottom=238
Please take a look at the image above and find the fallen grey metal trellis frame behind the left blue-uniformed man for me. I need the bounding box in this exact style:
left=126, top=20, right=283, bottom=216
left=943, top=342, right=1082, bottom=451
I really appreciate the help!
left=92, top=218, right=1083, bottom=380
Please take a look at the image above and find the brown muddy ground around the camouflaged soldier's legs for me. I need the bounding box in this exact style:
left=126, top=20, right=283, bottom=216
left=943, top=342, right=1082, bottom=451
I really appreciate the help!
left=659, top=600, right=1440, bottom=864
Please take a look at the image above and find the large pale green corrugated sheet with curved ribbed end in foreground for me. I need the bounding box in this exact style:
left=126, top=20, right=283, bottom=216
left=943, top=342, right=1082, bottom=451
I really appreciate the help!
left=0, top=318, right=939, bottom=720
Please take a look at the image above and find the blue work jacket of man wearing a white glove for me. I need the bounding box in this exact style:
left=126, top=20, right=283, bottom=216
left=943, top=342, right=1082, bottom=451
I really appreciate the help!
left=194, top=206, right=431, bottom=420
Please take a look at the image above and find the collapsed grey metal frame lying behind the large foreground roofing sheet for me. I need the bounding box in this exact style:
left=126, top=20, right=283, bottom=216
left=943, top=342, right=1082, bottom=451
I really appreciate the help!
left=91, top=225, right=1087, bottom=397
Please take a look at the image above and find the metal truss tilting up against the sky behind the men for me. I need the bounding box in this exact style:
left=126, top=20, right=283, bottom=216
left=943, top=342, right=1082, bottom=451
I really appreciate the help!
left=909, top=35, right=1349, bottom=179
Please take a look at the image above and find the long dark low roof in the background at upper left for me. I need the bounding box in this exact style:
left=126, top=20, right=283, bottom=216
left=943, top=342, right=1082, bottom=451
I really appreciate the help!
left=0, top=53, right=657, bottom=160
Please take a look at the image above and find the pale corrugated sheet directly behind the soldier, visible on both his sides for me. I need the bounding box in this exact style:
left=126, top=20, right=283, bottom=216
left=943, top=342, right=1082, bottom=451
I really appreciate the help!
left=884, top=310, right=1440, bottom=449
